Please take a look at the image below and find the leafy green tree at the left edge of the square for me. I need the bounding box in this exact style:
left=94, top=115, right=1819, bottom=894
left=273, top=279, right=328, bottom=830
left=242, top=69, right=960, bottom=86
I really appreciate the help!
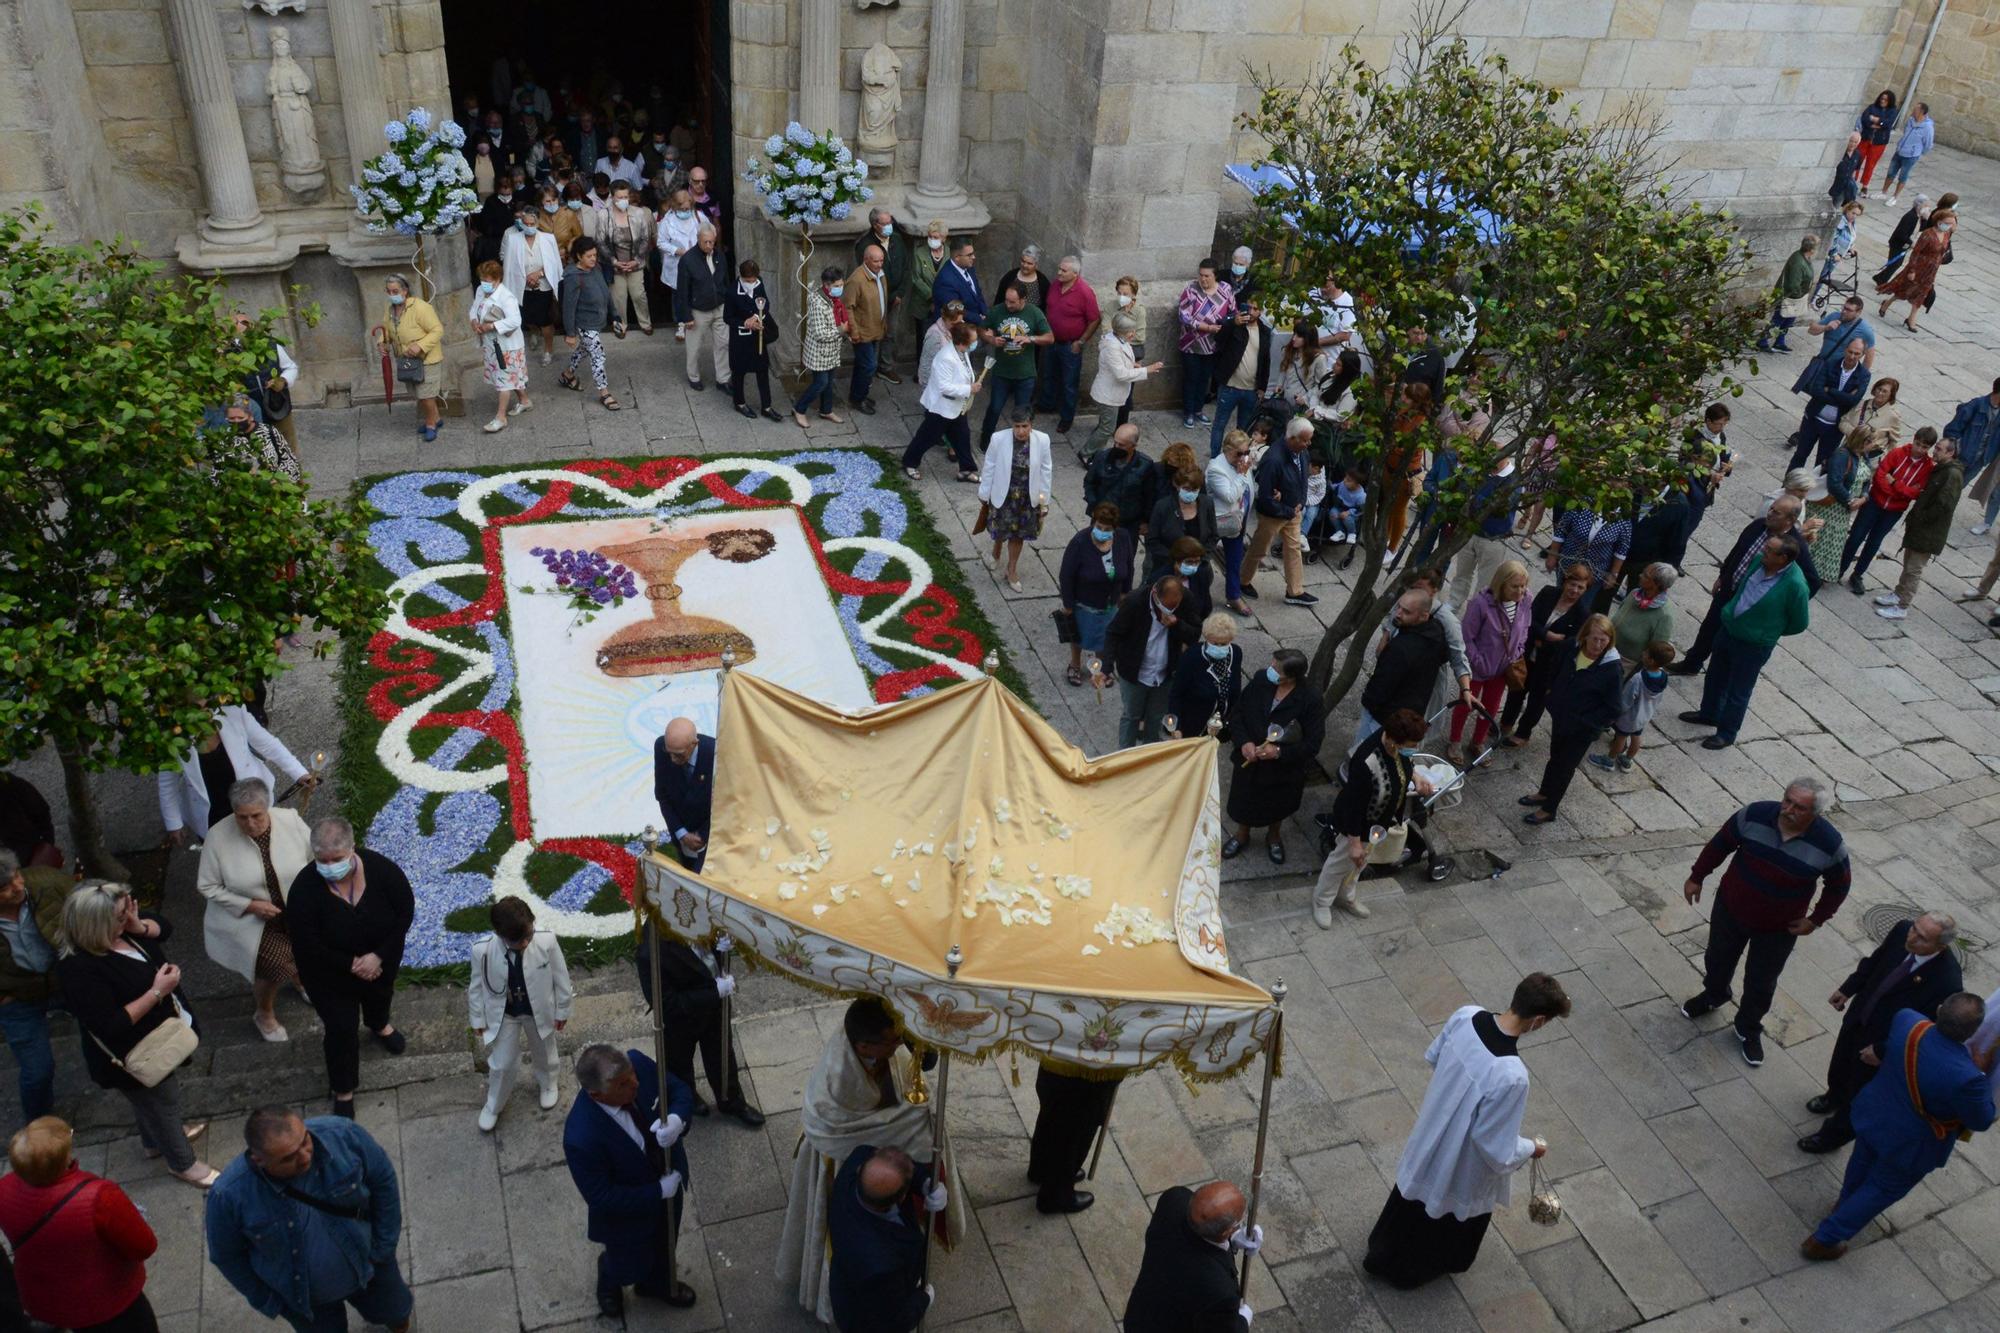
left=0, top=210, right=382, bottom=877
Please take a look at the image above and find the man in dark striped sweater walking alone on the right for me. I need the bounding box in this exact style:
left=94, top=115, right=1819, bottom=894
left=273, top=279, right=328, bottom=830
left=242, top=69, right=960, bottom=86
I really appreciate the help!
left=1680, top=779, right=1850, bottom=1067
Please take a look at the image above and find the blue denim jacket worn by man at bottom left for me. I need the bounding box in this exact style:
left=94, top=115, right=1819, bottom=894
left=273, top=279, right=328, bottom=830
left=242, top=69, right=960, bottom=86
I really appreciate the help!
left=206, top=1115, right=402, bottom=1319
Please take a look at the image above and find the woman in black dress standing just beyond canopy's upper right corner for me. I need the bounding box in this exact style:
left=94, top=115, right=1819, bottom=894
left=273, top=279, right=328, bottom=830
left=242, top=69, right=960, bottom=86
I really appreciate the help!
left=1222, top=648, right=1326, bottom=865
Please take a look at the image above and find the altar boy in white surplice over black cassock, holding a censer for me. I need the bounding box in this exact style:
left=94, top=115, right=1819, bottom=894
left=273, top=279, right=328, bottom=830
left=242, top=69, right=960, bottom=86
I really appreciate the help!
left=1362, top=973, right=1570, bottom=1289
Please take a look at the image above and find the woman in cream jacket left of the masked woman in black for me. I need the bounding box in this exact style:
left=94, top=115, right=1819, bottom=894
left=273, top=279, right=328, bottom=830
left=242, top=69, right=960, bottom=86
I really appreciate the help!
left=194, top=779, right=312, bottom=1041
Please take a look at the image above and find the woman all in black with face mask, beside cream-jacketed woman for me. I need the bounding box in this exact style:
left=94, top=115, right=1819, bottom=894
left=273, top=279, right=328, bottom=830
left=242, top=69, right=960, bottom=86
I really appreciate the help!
left=284, top=819, right=416, bottom=1121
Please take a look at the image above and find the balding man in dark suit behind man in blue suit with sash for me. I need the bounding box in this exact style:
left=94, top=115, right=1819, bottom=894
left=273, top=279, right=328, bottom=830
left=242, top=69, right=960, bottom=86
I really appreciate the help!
left=1798, top=913, right=1966, bottom=1153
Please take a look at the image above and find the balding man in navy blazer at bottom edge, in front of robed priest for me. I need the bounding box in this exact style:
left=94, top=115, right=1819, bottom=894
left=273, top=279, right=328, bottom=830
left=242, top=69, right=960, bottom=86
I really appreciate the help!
left=826, top=1143, right=930, bottom=1333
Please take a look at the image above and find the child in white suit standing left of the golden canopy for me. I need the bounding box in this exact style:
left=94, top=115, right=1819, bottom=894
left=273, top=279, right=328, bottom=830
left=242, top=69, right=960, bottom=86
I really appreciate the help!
left=466, top=895, right=574, bottom=1133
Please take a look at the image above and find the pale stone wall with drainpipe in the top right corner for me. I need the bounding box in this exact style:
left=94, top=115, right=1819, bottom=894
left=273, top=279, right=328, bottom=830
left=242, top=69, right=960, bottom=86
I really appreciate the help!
left=1856, top=0, right=2000, bottom=161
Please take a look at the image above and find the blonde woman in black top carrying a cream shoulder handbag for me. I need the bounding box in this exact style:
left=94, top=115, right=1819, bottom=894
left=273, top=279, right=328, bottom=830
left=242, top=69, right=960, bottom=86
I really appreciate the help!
left=56, top=881, right=220, bottom=1189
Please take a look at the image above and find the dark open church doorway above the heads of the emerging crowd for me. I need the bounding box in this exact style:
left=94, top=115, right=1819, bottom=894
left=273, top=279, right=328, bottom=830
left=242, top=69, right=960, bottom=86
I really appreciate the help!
left=440, top=0, right=736, bottom=216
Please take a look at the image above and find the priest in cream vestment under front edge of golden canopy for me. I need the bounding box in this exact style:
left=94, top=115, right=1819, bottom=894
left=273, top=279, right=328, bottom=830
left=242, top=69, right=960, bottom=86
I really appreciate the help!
left=778, top=999, right=966, bottom=1323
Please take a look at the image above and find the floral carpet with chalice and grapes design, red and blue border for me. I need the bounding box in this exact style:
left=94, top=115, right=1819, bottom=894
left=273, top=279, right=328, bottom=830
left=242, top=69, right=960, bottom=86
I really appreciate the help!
left=340, top=450, right=1018, bottom=969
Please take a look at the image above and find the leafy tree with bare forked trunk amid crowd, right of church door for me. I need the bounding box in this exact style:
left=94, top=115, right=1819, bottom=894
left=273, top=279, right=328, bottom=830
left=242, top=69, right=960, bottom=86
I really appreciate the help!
left=1246, top=2, right=1760, bottom=705
